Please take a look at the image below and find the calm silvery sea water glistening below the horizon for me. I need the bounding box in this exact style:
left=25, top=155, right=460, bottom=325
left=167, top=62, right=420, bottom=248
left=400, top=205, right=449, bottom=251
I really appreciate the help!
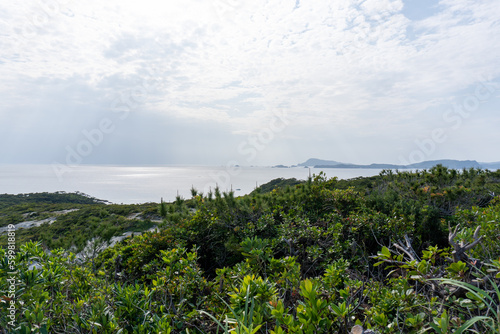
left=0, top=165, right=380, bottom=204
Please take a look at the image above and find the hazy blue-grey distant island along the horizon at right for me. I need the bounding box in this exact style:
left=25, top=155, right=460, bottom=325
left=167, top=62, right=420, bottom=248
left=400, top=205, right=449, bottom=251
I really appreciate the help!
left=298, top=158, right=500, bottom=170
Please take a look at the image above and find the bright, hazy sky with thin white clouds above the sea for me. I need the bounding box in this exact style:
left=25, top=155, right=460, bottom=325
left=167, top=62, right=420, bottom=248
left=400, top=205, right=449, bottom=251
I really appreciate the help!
left=0, top=0, right=500, bottom=166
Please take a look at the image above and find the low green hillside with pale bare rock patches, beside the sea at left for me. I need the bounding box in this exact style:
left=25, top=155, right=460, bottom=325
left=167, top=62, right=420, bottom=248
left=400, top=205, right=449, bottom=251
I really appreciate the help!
left=0, top=192, right=160, bottom=252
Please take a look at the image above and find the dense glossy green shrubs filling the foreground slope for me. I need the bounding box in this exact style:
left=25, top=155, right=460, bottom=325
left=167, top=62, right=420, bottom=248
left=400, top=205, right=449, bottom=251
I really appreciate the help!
left=0, top=166, right=500, bottom=333
